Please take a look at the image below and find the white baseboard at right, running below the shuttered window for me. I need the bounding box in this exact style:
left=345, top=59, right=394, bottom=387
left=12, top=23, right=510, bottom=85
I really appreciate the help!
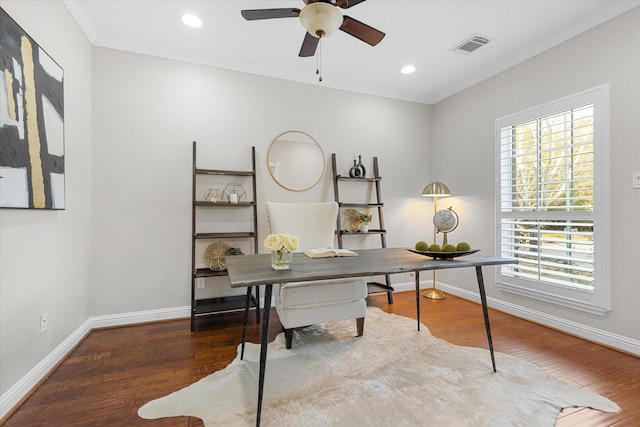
left=393, top=280, right=640, bottom=356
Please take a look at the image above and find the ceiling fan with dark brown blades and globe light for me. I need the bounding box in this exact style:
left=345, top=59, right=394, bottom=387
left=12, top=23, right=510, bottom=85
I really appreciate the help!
left=241, top=0, right=385, bottom=57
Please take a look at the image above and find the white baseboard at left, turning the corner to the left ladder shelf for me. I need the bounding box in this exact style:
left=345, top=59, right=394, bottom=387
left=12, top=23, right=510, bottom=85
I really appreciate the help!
left=0, top=306, right=191, bottom=419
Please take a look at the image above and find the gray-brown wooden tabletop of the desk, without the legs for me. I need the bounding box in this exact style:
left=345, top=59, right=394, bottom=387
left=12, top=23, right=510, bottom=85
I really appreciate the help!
left=225, top=248, right=517, bottom=288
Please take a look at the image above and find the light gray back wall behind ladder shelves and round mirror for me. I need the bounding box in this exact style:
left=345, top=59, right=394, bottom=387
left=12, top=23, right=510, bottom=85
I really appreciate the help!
left=90, top=48, right=431, bottom=316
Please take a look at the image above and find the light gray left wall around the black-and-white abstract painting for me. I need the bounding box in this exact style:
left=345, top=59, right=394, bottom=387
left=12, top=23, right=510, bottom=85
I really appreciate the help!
left=0, top=1, right=92, bottom=393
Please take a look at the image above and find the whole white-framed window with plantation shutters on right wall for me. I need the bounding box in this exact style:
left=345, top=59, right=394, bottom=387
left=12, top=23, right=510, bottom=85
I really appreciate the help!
left=496, top=86, right=610, bottom=314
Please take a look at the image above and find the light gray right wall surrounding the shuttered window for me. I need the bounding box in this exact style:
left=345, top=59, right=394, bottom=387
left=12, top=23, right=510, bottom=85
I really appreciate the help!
left=432, top=8, right=640, bottom=340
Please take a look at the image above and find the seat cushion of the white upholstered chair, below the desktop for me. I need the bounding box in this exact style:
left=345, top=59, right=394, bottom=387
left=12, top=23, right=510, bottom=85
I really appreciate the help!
left=278, top=278, right=367, bottom=308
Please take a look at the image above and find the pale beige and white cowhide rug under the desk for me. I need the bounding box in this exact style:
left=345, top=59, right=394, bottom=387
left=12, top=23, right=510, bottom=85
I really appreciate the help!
left=138, top=308, right=620, bottom=427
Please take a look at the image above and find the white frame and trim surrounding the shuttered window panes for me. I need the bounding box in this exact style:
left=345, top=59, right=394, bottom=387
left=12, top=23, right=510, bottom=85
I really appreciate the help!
left=494, top=84, right=611, bottom=315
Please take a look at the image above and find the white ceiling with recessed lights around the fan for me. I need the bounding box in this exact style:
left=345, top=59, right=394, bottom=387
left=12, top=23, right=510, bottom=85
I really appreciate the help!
left=64, top=0, right=640, bottom=104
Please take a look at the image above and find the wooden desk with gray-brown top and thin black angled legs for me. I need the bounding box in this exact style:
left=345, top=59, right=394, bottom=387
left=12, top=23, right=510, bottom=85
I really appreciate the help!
left=225, top=248, right=517, bottom=426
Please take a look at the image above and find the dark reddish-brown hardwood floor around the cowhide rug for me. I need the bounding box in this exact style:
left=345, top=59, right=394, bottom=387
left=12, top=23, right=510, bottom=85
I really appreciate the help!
left=0, top=291, right=640, bottom=427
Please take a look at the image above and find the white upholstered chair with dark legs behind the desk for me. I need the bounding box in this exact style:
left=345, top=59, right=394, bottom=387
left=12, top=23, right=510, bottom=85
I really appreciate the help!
left=267, top=202, right=367, bottom=348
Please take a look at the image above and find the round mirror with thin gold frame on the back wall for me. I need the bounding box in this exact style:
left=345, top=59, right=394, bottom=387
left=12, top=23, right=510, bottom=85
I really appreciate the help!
left=267, top=131, right=325, bottom=191
